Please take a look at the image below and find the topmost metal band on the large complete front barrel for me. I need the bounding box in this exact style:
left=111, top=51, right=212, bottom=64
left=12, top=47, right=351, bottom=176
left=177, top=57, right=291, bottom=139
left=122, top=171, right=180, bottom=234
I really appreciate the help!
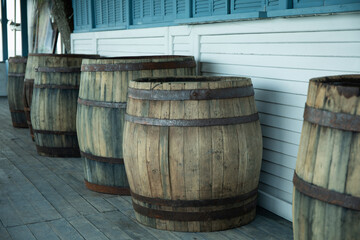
left=128, top=85, right=254, bottom=101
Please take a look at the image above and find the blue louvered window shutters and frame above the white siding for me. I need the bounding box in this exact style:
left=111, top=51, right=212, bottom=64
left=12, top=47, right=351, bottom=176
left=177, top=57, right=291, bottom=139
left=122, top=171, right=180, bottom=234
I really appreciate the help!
left=72, top=0, right=360, bottom=32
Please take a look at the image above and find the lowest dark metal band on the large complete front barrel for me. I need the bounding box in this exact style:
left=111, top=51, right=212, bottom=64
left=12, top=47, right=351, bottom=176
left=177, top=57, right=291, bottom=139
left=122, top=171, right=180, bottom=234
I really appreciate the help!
left=133, top=199, right=256, bottom=221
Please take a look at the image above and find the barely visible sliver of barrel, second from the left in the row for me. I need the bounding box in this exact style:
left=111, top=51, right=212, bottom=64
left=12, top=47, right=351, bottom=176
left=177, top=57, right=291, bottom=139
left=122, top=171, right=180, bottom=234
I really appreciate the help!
left=23, top=53, right=37, bottom=141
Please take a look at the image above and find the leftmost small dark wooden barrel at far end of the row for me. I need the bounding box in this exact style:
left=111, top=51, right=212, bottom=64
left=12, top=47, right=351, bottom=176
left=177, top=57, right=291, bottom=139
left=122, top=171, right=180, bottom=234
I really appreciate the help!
left=7, top=57, right=28, bottom=128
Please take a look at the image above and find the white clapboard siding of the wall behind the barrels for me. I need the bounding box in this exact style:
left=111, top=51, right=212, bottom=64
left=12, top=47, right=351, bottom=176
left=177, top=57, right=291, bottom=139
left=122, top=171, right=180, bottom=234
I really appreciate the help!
left=71, top=13, right=360, bottom=221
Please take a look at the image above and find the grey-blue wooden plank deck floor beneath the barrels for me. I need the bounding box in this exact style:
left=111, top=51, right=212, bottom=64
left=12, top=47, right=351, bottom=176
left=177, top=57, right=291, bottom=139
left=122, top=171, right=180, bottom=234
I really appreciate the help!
left=0, top=97, right=292, bottom=240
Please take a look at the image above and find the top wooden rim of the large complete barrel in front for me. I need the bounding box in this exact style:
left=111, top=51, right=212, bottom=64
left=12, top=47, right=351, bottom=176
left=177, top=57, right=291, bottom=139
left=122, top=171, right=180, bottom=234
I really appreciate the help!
left=131, top=76, right=252, bottom=86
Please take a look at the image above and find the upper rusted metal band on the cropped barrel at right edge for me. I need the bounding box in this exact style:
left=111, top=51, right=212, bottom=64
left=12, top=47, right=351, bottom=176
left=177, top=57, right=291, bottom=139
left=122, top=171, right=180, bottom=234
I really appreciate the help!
left=304, top=105, right=360, bottom=132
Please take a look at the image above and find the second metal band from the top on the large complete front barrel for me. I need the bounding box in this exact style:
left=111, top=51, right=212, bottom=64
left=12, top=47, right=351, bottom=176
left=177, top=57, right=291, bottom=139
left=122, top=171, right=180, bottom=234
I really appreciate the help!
left=125, top=113, right=259, bottom=127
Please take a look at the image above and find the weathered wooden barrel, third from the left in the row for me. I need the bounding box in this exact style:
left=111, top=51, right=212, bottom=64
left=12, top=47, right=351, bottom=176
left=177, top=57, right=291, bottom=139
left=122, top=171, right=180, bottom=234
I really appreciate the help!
left=30, top=54, right=98, bottom=157
